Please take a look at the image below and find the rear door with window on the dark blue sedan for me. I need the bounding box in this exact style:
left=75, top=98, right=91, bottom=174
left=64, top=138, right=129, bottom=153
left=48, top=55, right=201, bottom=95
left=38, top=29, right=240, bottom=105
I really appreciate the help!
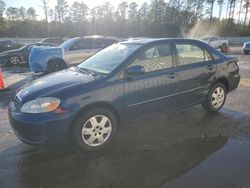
left=176, top=42, right=216, bottom=105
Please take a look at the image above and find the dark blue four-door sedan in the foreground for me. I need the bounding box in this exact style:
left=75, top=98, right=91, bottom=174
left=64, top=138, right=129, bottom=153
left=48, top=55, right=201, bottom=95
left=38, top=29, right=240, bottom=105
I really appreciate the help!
left=9, top=39, right=240, bottom=150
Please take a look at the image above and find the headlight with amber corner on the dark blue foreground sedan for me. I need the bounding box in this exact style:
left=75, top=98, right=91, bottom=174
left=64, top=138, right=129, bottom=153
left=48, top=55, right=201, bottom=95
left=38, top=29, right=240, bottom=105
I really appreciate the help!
left=20, top=97, right=60, bottom=114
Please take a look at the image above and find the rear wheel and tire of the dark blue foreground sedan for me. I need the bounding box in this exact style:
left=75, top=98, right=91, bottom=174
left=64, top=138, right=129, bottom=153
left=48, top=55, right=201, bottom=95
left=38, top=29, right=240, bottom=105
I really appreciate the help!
left=202, top=83, right=227, bottom=112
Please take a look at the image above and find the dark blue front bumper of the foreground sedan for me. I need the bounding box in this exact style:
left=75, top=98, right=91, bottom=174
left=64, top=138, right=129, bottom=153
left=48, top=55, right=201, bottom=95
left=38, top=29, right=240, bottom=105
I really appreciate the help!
left=9, top=108, right=73, bottom=145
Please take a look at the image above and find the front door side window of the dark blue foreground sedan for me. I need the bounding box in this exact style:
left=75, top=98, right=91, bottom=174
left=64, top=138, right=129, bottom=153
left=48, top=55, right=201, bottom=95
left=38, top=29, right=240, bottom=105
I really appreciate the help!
left=131, top=44, right=173, bottom=72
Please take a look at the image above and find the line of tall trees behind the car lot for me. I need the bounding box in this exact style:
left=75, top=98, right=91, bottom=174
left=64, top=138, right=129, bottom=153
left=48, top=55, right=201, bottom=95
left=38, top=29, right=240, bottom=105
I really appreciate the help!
left=0, top=0, right=250, bottom=37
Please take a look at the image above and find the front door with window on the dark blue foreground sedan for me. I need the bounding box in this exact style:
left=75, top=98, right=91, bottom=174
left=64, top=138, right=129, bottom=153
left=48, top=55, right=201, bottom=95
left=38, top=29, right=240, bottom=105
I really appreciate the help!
left=124, top=43, right=179, bottom=120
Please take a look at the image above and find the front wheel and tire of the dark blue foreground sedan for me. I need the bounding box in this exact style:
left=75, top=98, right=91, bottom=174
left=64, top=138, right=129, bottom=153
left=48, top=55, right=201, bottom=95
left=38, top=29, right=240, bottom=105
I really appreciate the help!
left=72, top=108, right=117, bottom=151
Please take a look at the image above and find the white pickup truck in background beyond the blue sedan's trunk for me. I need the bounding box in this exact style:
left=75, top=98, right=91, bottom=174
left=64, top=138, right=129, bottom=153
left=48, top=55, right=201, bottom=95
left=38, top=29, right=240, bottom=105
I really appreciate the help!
left=200, top=36, right=229, bottom=52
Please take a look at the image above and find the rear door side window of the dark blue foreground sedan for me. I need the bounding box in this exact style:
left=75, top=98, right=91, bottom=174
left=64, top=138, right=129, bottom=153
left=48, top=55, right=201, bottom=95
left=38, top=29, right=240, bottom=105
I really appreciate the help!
left=176, top=44, right=213, bottom=65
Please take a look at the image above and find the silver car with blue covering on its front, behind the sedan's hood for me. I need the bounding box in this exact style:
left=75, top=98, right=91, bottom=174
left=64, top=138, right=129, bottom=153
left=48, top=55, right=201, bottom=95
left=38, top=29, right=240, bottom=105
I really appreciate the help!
left=29, top=35, right=120, bottom=72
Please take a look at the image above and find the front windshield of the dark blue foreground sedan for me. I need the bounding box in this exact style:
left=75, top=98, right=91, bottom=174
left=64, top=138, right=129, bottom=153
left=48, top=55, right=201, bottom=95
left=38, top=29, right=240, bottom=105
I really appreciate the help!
left=78, top=43, right=140, bottom=74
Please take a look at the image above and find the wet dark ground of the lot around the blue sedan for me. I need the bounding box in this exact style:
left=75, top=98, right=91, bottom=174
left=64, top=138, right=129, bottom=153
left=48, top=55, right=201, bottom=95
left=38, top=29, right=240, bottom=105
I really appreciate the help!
left=0, top=47, right=250, bottom=188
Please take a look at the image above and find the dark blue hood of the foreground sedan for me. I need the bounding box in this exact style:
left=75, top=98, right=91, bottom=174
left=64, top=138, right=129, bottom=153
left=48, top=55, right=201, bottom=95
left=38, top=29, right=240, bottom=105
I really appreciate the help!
left=17, top=67, right=101, bottom=103
